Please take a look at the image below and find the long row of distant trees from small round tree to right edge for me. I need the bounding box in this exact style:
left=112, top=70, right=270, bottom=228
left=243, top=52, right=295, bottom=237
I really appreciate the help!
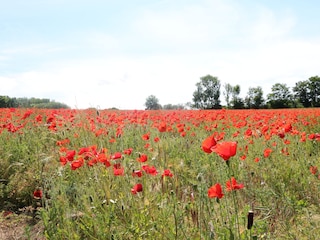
left=145, top=75, right=320, bottom=110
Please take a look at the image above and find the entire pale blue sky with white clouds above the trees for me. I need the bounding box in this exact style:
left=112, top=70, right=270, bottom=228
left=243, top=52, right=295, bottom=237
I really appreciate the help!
left=0, top=0, right=320, bottom=109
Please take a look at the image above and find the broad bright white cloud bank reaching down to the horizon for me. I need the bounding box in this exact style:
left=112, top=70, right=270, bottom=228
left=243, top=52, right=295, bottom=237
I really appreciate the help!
left=0, top=0, right=320, bottom=109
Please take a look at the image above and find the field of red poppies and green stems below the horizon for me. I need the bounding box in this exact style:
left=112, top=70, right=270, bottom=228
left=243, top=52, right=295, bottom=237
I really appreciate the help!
left=0, top=108, right=320, bottom=239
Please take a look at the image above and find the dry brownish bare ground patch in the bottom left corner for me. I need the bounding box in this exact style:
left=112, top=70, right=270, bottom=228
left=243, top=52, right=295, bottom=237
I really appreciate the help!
left=0, top=211, right=45, bottom=240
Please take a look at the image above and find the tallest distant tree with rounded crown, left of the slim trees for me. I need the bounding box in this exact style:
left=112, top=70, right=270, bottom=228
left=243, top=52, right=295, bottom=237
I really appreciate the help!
left=192, top=75, right=221, bottom=109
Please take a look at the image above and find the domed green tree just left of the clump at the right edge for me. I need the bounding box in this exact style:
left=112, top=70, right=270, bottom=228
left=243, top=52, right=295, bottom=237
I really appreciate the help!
left=268, top=83, right=292, bottom=108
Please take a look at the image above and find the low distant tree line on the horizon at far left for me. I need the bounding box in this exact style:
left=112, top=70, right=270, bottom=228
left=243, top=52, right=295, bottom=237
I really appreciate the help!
left=0, top=96, right=69, bottom=109
